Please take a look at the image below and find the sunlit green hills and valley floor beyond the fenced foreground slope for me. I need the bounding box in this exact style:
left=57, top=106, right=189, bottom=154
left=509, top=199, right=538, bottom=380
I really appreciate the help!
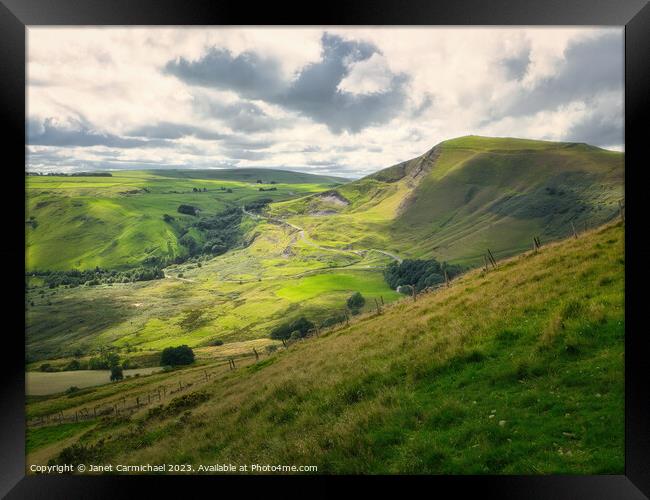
left=26, top=136, right=623, bottom=366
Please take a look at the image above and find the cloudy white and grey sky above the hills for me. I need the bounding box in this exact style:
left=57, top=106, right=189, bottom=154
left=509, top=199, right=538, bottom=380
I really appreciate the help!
left=26, top=27, right=624, bottom=178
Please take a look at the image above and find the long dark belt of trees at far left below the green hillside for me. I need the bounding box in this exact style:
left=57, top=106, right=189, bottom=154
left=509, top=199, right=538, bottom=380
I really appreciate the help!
left=27, top=265, right=165, bottom=288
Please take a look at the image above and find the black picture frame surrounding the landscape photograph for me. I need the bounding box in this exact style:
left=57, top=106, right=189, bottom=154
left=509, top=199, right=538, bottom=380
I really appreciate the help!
left=0, top=0, right=650, bottom=499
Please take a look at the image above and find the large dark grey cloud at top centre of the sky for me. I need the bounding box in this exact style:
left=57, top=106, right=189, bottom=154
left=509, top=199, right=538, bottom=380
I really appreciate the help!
left=165, top=33, right=409, bottom=134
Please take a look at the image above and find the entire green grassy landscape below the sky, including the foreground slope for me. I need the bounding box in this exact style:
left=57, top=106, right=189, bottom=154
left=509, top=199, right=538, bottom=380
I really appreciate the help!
left=26, top=136, right=624, bottom=473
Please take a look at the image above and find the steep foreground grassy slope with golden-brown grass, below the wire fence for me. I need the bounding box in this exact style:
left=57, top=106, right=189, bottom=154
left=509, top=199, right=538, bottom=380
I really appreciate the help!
left=33, top=223, right=625, bottom=474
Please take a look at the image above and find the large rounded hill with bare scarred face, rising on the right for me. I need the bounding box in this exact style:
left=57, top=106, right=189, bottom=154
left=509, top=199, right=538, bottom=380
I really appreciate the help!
left=272, top=136, right=624, bottom=264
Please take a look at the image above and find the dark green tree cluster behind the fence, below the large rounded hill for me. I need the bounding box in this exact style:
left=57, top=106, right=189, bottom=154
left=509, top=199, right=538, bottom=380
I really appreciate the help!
left=384, top=259, right=462, bottom=292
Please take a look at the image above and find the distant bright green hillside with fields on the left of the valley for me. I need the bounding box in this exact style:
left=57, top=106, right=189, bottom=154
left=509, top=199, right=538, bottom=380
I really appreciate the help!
left=25, top=169, right=334, bottom=271
